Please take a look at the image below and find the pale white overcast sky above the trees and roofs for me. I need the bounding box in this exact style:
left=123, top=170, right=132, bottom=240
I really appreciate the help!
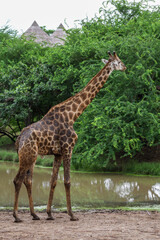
left=0, top=0, right=159, bottom=34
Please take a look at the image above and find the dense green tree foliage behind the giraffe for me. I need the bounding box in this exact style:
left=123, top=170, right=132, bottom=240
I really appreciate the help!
left=0, top=0, right=160, bottom=170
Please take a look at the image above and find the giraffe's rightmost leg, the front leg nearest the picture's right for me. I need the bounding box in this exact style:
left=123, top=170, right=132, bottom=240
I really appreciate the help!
left=64, top=159, right=79, bottom=221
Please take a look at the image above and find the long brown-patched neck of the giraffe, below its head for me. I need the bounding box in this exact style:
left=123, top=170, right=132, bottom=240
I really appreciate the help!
left=45, top=62, right=113, bottom=125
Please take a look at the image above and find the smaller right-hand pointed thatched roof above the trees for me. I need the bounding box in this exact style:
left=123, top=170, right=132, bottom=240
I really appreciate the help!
left=51, top=24, right=67, bottom=45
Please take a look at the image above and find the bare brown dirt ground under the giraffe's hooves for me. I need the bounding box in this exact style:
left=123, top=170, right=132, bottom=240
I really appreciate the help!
left=0, top=210, right=160, bottom=240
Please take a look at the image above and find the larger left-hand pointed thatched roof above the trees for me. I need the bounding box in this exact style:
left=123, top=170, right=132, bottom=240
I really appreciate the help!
left=23, top=21, right=52, bottom=44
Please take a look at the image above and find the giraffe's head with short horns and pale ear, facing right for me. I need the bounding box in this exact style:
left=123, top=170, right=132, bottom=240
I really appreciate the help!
left=102, top=52, right=126, bottom=71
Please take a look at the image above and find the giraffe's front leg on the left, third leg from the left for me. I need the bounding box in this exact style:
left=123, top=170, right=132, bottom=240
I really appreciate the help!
left=47, top=155, right=62, bottom=220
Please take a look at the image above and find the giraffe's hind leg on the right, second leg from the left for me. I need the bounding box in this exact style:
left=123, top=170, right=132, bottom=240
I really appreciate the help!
left=23, top=165, right=40, bottom=220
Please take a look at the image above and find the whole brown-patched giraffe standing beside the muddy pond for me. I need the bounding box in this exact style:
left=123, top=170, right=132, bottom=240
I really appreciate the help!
left=13, top=52, right=126, bottom=222
